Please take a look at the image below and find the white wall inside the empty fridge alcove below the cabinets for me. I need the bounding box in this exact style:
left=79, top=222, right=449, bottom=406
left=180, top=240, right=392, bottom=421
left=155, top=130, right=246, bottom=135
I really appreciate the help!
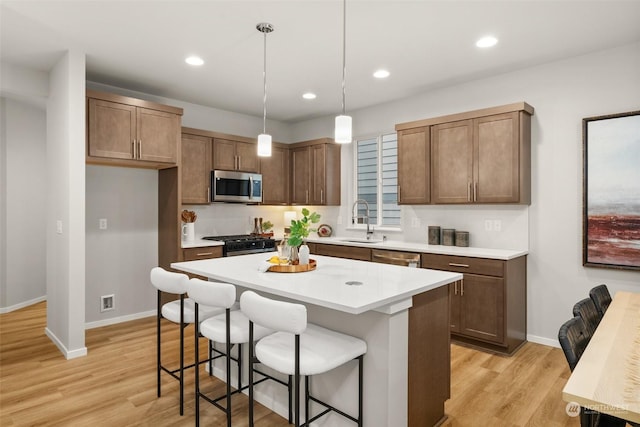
left=85, top=165, right=158, bottom=327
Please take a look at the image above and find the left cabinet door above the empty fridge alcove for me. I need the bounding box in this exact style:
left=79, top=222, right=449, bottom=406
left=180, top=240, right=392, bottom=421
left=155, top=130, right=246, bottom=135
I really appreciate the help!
left=88, top=98, right=136, bottom=159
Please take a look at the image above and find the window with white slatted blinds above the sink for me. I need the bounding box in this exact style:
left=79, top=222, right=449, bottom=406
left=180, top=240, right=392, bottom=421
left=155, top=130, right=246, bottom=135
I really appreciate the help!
left=355, top=133, right=400, bottom=227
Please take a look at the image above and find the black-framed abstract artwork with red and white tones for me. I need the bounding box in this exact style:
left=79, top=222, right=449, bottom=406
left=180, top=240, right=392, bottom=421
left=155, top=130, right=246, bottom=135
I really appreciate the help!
left=582, top=111, right=640, bottom=270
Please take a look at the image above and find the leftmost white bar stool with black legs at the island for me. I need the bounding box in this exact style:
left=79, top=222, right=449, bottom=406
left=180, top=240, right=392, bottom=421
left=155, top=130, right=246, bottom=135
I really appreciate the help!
left=150, top=267, right=224, bottom=415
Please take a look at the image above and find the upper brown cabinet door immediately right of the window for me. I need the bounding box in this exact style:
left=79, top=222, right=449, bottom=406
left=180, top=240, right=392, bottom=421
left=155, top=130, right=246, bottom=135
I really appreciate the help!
left=398, top=127, right=431, bottom=205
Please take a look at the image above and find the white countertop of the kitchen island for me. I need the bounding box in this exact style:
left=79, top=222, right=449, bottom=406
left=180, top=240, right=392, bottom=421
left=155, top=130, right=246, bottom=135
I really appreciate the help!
left=171, top=252, right=462, bottom=314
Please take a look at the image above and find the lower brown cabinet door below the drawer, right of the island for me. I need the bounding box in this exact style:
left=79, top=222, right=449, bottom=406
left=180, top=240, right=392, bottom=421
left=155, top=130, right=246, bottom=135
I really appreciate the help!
left=460, top=274, right=505, bottom=344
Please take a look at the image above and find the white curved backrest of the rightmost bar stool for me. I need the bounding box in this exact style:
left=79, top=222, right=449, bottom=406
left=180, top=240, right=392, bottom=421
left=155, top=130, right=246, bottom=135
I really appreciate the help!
left=240, top=291, right=307, bottom=335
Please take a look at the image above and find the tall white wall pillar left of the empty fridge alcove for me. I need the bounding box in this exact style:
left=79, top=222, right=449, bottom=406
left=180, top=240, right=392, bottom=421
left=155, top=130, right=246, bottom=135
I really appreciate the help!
left=45, top=51, right=87, bottom=359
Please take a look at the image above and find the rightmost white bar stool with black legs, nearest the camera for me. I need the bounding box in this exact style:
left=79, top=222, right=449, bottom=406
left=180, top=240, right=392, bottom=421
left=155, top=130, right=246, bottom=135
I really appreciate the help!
left=240, top=291, right=367, bottom=427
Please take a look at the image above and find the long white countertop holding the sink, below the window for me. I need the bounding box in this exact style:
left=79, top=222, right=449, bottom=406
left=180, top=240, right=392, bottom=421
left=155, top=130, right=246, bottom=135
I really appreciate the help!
left=307, top=237, right=528, bottom=261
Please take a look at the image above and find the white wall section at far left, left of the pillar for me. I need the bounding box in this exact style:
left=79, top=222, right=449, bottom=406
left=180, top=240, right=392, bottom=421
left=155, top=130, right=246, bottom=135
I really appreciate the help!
left=0, top=98, right=47, bottom=313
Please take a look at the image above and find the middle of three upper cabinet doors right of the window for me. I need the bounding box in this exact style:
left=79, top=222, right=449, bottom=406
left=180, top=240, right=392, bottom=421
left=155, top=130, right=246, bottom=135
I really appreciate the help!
left=431, top=120, right=473, bottom=204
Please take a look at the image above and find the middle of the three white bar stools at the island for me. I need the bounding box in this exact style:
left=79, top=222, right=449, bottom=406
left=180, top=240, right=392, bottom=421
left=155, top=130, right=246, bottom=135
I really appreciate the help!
left=187, top=278, right=273, bottom=427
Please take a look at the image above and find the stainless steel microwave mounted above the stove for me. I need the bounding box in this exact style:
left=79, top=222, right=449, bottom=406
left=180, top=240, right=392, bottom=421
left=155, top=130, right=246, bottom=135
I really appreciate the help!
left=211, top=170, right=262, bottom=203
